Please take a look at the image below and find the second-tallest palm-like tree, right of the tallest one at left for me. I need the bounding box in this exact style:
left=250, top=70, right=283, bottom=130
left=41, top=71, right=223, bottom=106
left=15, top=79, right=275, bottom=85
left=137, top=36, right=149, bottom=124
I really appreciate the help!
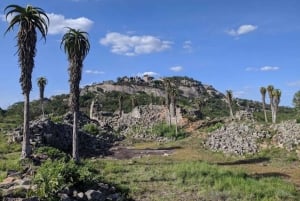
left=60, top=28, right=90, bottom=162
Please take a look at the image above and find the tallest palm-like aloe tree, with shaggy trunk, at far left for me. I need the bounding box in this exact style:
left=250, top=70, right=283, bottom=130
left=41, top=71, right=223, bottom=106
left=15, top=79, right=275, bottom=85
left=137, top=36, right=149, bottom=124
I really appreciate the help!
left=4, top=4, right=49, bottom=159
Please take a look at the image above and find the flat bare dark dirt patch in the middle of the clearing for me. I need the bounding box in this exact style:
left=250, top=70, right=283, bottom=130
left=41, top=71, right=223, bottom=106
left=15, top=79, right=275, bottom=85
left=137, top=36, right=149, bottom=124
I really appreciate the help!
left=109, top=147, right=176, bottom=159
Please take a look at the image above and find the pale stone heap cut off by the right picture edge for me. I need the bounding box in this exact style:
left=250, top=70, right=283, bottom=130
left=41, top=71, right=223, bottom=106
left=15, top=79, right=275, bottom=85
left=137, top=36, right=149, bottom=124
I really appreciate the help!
left=271, top=120, right=300, bottom=151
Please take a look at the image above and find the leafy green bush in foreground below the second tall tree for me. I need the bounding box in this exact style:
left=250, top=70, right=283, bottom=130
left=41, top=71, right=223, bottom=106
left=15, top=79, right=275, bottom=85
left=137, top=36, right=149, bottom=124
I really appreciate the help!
left=32, top=160, right=99, bottom=201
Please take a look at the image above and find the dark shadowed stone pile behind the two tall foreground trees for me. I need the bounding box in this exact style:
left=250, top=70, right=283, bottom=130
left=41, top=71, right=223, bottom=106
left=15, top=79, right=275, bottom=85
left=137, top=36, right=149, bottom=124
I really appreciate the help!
left=9, top=114, right=120, bottom=156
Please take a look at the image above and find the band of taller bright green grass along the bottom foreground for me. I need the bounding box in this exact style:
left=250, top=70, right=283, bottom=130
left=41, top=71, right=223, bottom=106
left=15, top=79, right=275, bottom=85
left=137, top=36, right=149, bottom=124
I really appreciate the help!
left=95, top=157, right=299, bottom=200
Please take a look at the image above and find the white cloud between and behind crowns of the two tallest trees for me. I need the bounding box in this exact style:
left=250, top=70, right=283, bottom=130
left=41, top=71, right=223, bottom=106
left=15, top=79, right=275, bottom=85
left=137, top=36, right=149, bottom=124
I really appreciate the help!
left=47, top=13, right=94, bottom=34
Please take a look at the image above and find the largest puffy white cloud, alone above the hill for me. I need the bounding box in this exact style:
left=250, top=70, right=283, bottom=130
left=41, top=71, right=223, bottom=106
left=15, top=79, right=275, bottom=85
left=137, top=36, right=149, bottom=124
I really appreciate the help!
left=100, top=32, right=172, bottom=56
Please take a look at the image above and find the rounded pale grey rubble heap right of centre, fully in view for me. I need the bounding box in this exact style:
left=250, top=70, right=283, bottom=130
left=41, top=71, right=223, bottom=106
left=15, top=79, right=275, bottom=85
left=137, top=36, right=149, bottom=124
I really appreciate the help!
left=205, top=122, right=271, bottom=155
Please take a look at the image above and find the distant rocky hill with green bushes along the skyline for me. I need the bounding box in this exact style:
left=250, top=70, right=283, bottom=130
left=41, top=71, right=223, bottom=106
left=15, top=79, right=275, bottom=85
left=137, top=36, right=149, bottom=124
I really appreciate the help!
left=0, top=75, right=296, bottom=121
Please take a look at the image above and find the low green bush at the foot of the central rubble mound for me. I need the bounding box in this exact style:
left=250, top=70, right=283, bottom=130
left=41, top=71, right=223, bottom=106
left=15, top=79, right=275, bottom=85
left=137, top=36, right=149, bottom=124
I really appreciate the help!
left=152, top=123, right=186, bottom=140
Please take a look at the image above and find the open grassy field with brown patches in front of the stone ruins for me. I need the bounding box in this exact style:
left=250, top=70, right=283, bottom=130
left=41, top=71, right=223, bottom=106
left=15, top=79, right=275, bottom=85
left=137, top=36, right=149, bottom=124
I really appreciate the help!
left=0, top=125, right=300, bottom=201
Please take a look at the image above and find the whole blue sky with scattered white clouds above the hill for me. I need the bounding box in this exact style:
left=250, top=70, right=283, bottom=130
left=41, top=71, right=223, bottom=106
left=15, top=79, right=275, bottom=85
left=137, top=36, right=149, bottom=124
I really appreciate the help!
left=0, top=0, right=300, bottom=108
